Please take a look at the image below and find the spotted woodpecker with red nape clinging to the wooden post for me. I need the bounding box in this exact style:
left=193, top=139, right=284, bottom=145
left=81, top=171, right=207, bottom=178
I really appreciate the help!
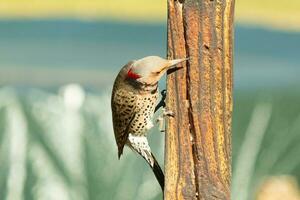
left=111, top=56, right=187, bottom=189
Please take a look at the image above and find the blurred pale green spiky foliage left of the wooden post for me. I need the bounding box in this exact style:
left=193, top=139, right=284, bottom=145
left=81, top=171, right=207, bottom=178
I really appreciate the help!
left=0, top=84, right=162, bottom=200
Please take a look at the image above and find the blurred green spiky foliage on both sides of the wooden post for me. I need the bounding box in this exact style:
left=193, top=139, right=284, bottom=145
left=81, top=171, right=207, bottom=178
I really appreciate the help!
left=0, top=84, right=300, bottom=200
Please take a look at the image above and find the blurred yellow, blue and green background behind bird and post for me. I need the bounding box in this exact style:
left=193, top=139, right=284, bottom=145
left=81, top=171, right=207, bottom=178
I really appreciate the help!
left=0, top=0, right=300, bottom=200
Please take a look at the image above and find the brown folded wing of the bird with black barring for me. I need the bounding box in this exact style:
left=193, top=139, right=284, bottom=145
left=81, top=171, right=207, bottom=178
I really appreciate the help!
left=112, top=89, right=137, bottom=158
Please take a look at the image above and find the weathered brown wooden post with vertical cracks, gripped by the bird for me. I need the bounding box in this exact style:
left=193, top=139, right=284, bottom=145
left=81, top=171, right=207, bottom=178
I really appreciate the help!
left=164, top=0, right=234, bottom=200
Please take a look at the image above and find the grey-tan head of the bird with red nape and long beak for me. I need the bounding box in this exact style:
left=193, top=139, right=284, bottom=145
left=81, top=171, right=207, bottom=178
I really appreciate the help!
left=127, top=56, right=187, bottom=85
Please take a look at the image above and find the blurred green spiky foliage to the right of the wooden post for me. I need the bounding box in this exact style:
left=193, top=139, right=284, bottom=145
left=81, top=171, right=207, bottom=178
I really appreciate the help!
left=232, top=94, right=300, bottom=200
